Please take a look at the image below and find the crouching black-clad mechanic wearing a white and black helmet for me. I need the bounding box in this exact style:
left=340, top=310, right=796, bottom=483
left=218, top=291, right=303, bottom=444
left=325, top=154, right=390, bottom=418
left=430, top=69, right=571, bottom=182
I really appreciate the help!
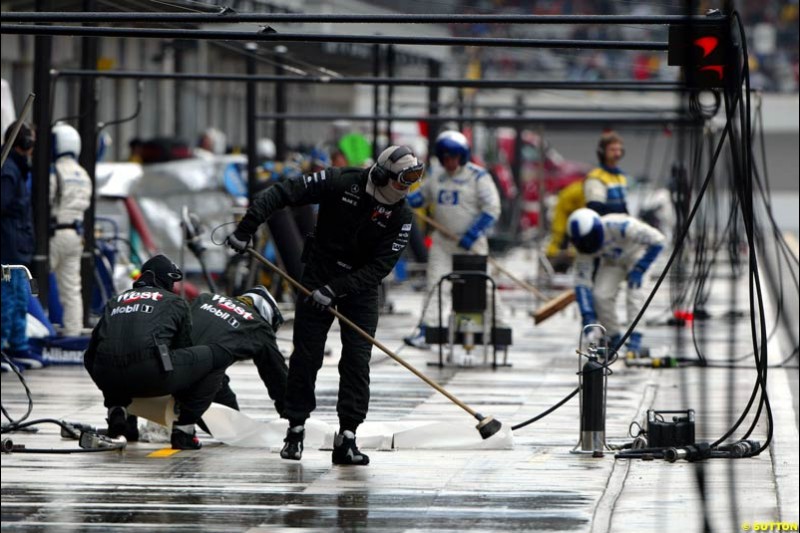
left=191, top=285, right=289, bottom=416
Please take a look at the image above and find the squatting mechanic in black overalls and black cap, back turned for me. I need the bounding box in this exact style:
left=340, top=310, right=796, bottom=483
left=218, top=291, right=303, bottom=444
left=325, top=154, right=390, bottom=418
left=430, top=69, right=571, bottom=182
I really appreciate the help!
left=84, top=255, right=233, bottom=450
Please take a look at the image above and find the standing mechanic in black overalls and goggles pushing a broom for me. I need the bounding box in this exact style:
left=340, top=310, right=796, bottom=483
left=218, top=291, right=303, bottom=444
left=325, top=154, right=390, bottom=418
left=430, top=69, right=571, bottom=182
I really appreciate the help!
left=226, top=146, right=424, bottom=465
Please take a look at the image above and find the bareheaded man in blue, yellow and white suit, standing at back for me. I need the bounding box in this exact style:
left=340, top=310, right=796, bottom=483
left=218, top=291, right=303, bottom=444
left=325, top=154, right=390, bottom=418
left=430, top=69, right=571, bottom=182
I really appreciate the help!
left=583, top=131, right=628, bottom=216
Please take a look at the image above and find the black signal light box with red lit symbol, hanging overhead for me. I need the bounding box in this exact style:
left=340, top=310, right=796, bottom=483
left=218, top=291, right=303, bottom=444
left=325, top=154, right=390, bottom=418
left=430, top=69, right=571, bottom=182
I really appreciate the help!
left=667, top=13, right=738, bottom=89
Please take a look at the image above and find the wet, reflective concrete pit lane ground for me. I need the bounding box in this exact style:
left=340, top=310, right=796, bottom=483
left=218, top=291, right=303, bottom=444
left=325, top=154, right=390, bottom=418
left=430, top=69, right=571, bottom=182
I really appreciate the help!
left=2, top=247, right=800, bottom=533
